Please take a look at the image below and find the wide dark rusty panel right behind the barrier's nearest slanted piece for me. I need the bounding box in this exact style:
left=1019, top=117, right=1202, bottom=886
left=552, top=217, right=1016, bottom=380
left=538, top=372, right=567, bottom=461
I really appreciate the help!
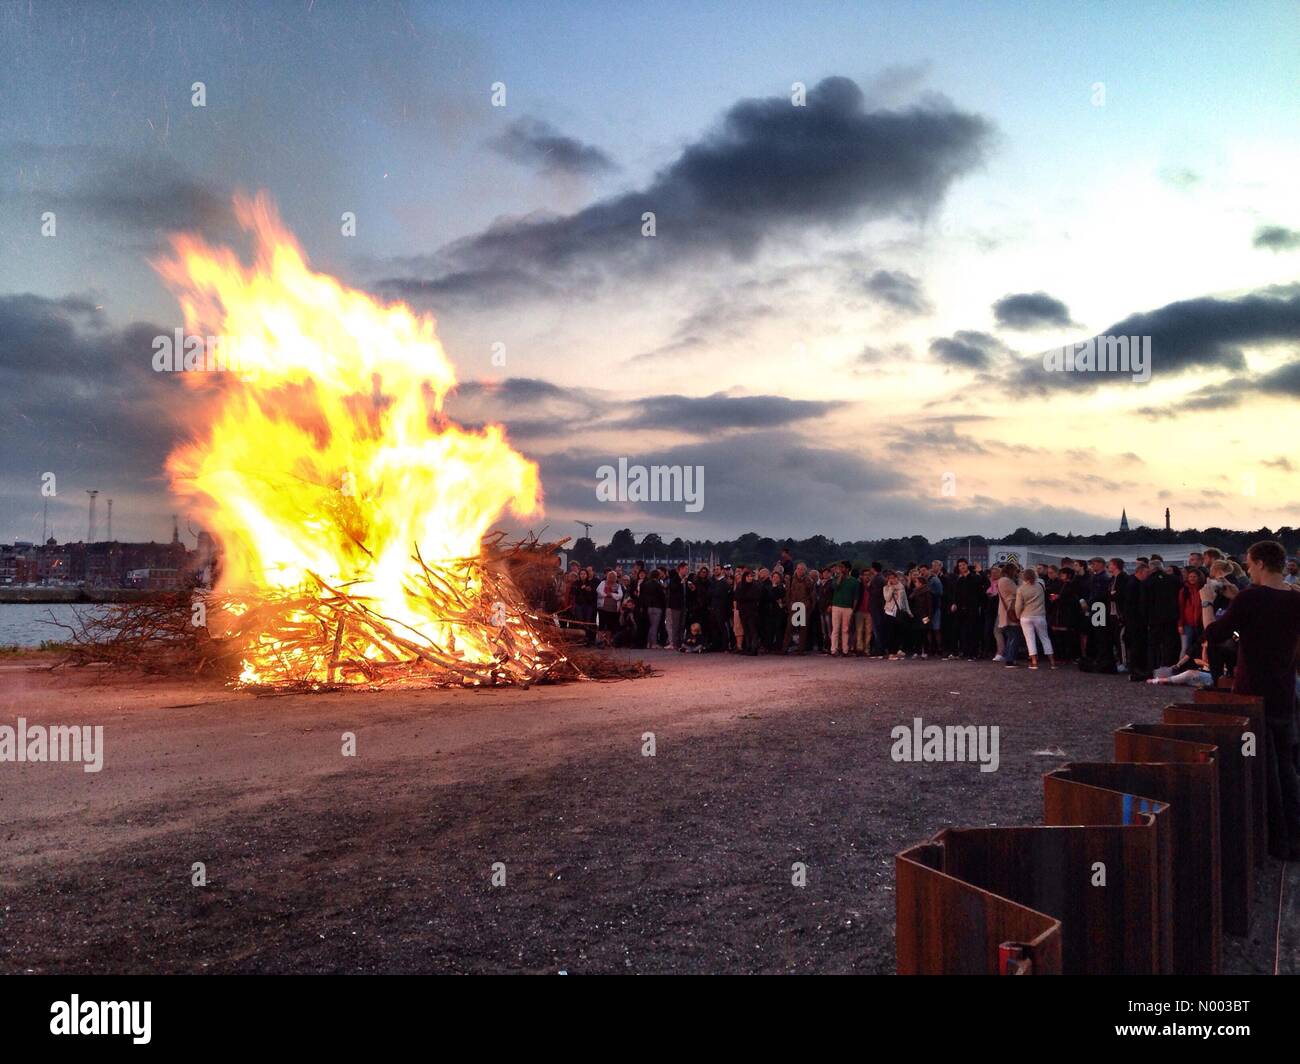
left=900, top=816, right=1158, bottom=974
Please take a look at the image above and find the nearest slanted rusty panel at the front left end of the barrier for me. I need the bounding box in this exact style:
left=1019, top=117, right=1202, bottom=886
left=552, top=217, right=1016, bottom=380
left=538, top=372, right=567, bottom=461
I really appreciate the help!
left=894, top=831, right=1061, bottom=976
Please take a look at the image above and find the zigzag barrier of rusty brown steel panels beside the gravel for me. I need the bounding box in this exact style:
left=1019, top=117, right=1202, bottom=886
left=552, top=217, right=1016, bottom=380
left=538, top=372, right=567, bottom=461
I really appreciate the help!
left=896, top=691, right=1266, bottom=974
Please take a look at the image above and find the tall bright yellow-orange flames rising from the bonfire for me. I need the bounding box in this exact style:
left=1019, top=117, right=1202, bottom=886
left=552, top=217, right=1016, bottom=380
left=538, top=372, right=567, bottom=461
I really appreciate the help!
left=155, top=195, right=541, bottom=682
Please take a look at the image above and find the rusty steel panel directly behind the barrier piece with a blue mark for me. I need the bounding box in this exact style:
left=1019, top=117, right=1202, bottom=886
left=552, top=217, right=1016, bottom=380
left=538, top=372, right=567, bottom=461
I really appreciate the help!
left=1069, top=759, right=1223, bottom=974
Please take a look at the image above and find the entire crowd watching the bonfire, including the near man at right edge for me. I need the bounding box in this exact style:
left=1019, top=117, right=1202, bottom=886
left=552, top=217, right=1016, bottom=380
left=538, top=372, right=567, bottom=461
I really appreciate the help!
left=555, top=540, right=1300, bottom=860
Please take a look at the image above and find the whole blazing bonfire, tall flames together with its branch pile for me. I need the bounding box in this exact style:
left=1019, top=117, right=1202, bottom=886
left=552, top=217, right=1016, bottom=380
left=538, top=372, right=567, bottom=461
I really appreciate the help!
left=50, top=198, right=645, bottom=691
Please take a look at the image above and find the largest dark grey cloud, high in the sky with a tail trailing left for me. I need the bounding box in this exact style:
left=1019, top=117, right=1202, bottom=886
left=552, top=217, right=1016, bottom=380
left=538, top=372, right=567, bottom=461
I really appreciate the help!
left=381, top=78, right=992, bottom=299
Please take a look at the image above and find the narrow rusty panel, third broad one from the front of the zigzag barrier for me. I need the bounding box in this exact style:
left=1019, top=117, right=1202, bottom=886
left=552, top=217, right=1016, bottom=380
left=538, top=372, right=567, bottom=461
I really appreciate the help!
left=1159, top=705, right=1255, bottom=935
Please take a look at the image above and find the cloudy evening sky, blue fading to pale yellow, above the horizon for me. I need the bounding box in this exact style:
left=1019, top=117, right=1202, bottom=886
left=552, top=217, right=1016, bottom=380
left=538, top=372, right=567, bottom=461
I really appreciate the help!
left=0, top=0, right=1300, bottom=542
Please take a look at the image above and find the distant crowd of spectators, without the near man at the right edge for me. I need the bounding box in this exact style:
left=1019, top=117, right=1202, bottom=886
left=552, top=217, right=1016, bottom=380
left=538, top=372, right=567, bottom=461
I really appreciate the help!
left=558, top=549, right=1300, bottom=680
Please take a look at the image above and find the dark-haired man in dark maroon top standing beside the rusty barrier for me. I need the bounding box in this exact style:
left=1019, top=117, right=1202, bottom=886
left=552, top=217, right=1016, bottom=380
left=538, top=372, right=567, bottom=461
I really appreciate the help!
left=1205, top=540, right=1300, bottom=861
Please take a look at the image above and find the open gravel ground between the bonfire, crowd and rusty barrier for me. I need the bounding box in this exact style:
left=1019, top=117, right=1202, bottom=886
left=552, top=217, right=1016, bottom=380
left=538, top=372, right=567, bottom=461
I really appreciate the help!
left=0, top=652, right=1300, bottom=973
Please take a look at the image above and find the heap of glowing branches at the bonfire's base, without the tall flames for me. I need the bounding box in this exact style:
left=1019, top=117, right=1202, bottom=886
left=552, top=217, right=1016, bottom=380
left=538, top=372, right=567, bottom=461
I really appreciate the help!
left=61, top=535, right=650, bottom=693
